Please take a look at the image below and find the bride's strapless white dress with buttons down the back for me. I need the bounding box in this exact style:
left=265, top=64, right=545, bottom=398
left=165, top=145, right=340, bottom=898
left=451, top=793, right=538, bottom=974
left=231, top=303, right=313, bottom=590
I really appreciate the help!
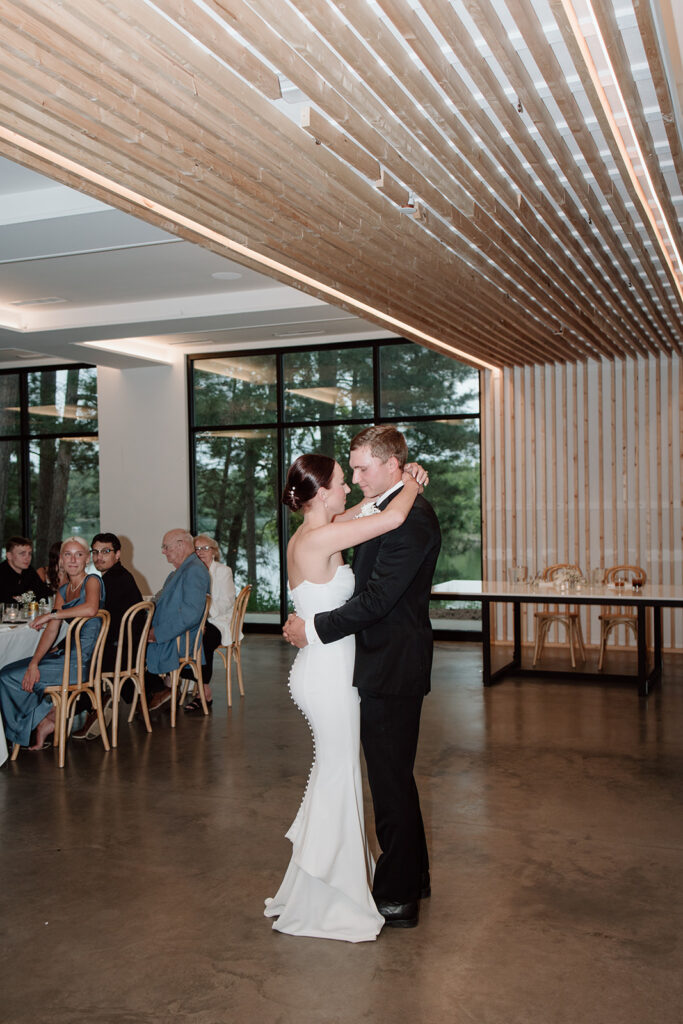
left=264, top=565, right=384, bottom=942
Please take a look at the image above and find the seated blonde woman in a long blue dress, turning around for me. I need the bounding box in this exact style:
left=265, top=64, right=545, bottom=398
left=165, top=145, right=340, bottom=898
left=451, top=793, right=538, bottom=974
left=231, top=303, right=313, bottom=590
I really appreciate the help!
left=0, top=537, right=104, bottom=751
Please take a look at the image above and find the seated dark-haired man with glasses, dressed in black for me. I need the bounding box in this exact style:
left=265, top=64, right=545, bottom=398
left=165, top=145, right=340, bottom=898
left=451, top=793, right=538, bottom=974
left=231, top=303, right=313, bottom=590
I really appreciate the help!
left=72, top=534, right=142, bottom=739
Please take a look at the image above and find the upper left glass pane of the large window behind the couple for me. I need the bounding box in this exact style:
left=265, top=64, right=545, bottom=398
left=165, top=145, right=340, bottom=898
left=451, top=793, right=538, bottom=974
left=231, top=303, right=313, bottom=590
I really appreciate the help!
left=193, top=355, right=278, bottom=428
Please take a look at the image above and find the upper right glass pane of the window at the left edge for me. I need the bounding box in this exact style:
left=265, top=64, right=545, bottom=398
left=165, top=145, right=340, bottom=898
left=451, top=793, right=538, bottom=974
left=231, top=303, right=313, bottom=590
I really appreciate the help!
left=27, top=368, right=97, bottom=434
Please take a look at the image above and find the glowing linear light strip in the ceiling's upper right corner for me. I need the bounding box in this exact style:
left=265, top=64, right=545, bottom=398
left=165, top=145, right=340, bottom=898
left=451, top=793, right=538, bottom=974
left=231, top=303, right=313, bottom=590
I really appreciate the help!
left=561, top=0, right=683, bottom=301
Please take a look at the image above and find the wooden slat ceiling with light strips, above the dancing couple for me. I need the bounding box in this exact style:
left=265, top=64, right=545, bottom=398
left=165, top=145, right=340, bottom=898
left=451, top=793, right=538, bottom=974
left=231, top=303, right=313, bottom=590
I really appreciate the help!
left=0, top=0, right=683, bottom=367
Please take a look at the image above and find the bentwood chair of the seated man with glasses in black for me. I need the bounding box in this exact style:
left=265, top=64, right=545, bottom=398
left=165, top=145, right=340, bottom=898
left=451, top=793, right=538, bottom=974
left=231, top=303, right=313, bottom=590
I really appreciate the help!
left=101, top=601, right=155, bottom=748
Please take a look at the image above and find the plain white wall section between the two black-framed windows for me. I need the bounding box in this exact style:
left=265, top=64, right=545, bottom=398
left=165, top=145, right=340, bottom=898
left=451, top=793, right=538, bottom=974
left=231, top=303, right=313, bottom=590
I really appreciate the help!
left=97, top=355, right=189, bottom=594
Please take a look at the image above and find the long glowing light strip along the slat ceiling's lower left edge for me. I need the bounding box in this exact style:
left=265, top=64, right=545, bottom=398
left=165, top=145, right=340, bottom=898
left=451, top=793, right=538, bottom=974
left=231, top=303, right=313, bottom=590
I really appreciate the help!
left=0, top=125, right=500, bottom=372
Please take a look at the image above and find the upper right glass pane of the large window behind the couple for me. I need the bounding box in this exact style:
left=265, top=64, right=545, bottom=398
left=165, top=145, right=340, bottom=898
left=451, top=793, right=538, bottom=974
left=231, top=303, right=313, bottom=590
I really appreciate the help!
left=380, top=342, right=479, bottom=417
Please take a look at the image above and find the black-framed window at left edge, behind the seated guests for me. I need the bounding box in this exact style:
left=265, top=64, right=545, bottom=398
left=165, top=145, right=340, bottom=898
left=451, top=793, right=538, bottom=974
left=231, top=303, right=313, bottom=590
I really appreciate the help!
left=0, top=366, right=99, bottom=565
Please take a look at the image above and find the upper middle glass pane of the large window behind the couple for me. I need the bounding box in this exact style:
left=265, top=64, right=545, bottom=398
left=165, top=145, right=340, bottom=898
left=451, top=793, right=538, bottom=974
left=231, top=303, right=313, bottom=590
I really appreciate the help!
left=284, top=347, right=374, bottom=423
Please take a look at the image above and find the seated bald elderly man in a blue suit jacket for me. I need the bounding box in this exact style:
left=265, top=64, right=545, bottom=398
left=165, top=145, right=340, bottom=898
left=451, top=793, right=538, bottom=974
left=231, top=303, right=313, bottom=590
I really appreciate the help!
left=147, top=529, right=206, bottom=711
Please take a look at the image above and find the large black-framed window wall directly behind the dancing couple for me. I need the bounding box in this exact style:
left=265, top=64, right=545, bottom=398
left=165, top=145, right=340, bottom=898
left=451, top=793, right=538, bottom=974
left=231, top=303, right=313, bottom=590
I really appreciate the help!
left=188, top=340, right=481, bottom=631
